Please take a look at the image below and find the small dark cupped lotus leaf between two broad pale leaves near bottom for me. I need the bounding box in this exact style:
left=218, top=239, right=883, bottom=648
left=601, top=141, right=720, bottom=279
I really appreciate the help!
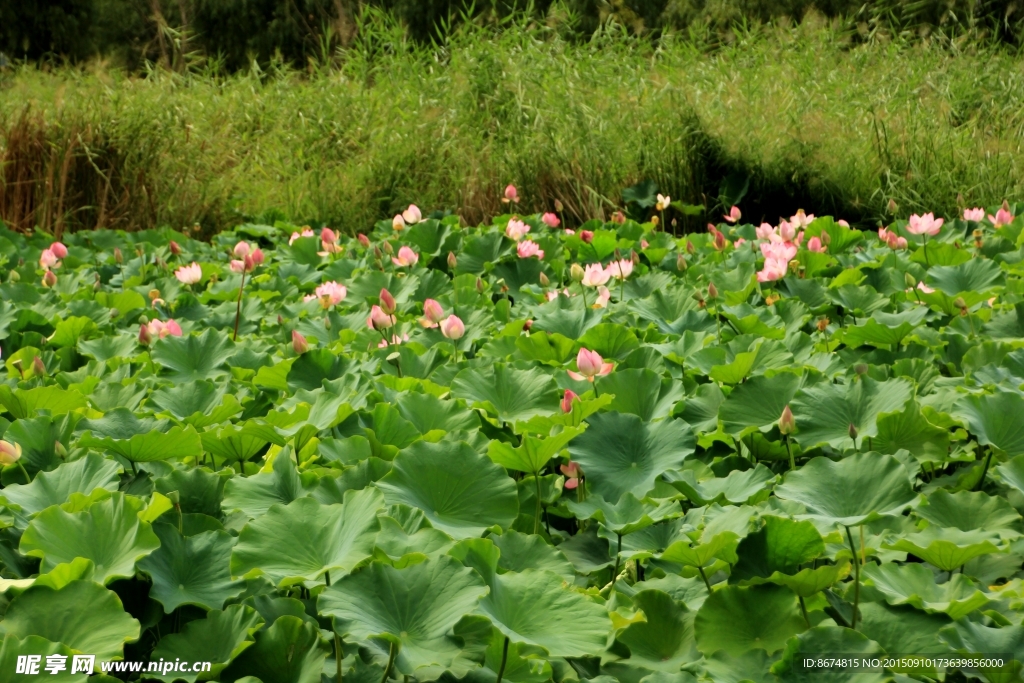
left=617, top=584, right=700, bottom=673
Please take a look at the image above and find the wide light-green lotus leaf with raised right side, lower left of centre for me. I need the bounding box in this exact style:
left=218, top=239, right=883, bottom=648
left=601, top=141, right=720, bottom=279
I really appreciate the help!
left=231, top=488, right=384, bottom=585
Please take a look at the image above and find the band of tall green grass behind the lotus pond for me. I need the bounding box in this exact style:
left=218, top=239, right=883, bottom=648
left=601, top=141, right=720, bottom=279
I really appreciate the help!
left=0, top=16, right=1024, bottom=231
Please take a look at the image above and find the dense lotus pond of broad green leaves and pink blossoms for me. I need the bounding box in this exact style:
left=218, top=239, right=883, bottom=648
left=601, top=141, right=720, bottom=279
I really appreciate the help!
left=0, top=196, right=1024, bottom=683
